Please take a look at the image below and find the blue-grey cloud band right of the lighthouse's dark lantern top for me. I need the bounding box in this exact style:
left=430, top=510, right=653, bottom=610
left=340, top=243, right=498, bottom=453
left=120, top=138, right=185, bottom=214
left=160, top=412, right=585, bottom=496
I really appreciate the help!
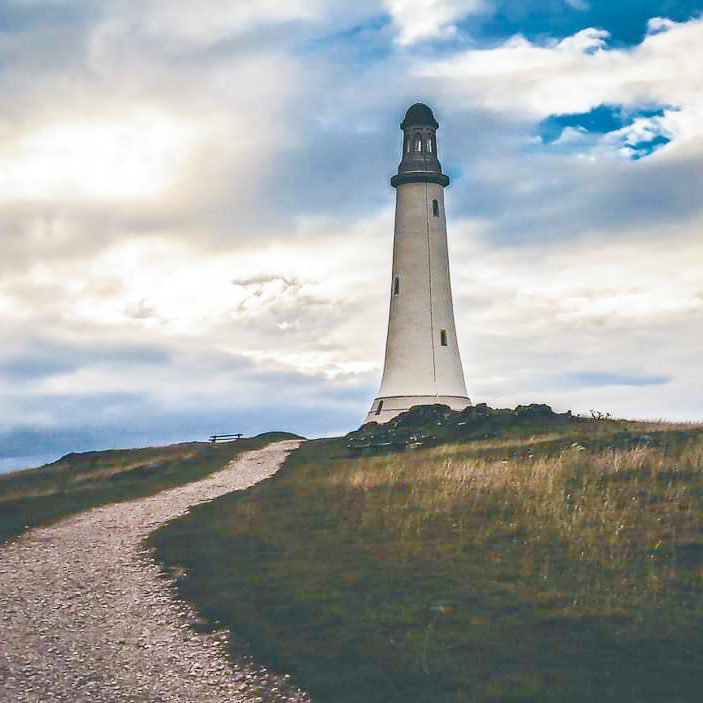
left=440, top=104, right=703, bottom=245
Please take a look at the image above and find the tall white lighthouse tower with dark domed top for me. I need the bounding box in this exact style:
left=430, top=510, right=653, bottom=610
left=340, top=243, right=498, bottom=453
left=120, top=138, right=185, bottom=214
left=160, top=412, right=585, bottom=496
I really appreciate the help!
left=366, top=103, right=471, bottom=423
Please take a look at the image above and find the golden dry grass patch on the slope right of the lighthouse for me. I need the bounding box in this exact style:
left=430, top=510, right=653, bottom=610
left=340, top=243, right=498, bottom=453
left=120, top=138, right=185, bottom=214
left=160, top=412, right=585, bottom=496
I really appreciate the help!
left=329, top=438, right=703, bottom=592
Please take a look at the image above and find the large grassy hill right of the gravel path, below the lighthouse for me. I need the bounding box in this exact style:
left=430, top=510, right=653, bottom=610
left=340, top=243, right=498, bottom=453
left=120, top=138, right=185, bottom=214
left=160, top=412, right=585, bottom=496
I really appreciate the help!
left=151, top=413, right=703, bottom=703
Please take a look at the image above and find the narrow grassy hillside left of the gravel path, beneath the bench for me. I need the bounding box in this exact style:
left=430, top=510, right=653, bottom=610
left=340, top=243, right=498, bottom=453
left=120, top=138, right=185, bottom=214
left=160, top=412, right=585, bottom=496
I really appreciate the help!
left=0, top=432, right=296, bottom=544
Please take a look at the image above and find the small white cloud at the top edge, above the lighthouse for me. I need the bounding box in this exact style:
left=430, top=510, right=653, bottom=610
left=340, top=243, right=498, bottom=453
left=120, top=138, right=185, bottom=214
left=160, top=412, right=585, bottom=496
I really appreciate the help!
left=384, top=0, right=486, bottom=45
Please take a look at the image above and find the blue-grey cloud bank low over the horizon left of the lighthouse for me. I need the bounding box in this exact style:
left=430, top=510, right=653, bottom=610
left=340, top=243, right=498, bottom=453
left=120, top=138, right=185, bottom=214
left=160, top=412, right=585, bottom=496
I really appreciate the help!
left=0, top=352, right=372, bottom=468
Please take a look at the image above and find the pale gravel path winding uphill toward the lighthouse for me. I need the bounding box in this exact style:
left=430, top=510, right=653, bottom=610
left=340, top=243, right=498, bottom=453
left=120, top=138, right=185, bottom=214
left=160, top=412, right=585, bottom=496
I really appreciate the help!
left=0, top=441, right=308, bottom=703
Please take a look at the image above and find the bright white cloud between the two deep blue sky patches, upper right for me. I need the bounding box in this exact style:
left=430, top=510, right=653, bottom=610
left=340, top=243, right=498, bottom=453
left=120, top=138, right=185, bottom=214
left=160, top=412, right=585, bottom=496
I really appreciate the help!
left=416, top=20, right=703, bottom=129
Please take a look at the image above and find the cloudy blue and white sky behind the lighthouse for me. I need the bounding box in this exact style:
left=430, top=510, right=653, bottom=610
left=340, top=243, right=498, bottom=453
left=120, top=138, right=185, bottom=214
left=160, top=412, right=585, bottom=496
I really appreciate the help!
left=0, top=0, right=703, bottom=470
